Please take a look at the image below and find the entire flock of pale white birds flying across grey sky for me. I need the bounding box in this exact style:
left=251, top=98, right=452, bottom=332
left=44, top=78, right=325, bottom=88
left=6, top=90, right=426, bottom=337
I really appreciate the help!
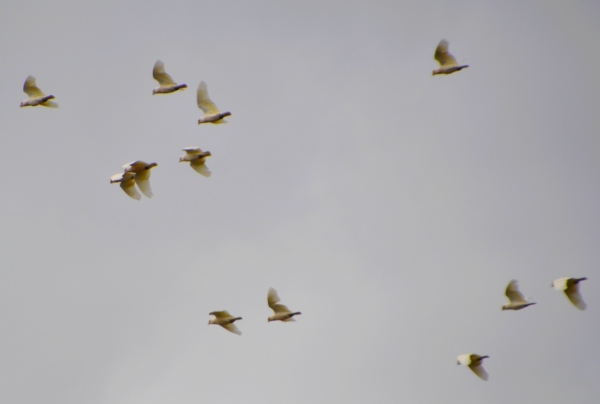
left=21, top=39, right=587, bottom=380
